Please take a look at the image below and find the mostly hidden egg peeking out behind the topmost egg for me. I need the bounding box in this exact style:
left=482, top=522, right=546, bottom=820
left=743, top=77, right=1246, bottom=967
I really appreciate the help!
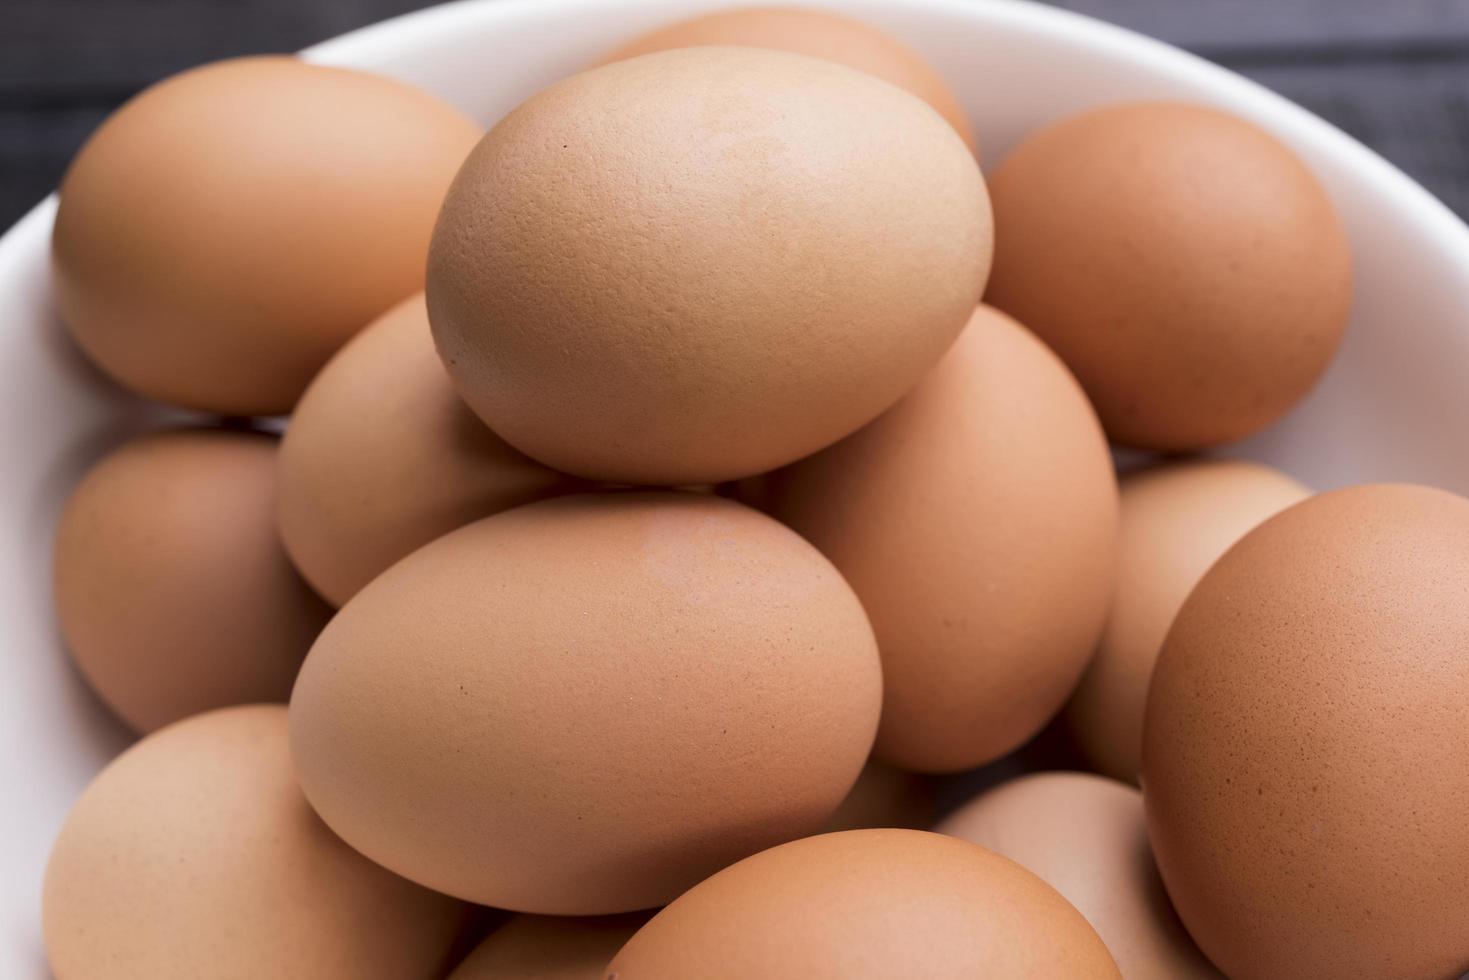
left=601, top=7, right=974, bottom=147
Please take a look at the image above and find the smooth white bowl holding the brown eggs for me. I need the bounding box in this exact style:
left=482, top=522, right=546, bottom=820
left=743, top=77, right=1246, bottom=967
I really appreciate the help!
left=0, top=0, right=1469, bottom=980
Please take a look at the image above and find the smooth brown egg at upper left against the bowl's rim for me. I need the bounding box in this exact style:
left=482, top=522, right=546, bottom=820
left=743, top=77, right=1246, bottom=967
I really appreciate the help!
left=53, top=57, right=480, bottom=416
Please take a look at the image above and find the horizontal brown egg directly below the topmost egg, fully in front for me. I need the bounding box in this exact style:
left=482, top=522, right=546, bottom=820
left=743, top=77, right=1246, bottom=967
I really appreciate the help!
left=291, top=492, right=881, bottom=915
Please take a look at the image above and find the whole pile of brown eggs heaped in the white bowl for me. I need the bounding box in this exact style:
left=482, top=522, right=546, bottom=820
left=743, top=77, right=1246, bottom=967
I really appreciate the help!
left=43, top=9, right=1469, bottom=980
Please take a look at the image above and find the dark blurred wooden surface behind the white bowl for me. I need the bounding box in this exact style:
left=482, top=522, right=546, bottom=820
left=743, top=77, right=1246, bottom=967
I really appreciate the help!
left=0, top=0, right=1469, bottom=229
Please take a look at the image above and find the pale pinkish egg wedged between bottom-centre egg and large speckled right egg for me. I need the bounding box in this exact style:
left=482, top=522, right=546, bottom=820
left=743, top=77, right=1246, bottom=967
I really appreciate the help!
left=939, top=773, right=1221, bottom=980
